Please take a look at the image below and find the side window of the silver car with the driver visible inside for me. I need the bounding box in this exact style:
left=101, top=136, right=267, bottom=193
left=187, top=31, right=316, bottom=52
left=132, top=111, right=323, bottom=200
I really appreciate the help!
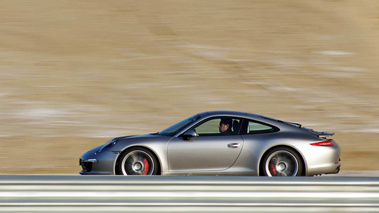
left=194, top=117, right=241, bottom=136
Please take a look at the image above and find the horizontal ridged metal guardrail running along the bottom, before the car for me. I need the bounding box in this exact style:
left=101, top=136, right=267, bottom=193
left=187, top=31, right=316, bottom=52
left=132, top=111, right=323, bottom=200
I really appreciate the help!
left=0, top=175, right=379, bottom=213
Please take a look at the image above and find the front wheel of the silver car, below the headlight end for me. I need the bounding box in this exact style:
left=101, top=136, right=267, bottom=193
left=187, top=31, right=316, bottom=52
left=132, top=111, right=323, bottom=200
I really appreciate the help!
left=118, top=147, right=159, bottom=175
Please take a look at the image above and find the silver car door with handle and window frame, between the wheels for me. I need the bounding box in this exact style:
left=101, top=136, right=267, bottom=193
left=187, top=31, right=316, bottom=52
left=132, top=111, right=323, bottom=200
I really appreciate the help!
left=168, top=117, right=243, bottom=173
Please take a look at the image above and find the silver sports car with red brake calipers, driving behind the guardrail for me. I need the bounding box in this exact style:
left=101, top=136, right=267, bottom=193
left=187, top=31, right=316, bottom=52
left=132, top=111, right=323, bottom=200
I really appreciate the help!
left=80, top=111, right=341, bottom=176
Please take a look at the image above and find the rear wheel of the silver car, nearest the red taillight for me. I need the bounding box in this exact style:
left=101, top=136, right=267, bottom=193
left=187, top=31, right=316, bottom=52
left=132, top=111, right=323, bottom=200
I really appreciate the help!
left=261, top=147, right=303, bottom=177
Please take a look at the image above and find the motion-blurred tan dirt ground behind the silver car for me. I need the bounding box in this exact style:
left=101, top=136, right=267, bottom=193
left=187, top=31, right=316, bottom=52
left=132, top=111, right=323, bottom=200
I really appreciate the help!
left=0, top=0, right=379, bottom=174
